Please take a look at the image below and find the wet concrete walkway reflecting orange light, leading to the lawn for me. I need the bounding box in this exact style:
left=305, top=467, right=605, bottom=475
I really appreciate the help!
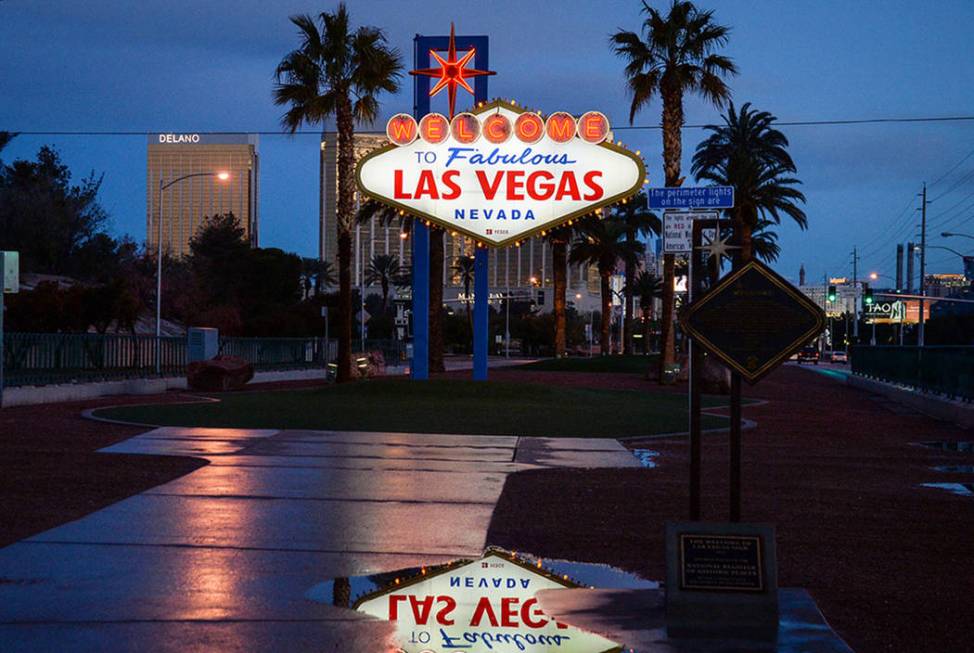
left=0, top=428, right=638, bottom=653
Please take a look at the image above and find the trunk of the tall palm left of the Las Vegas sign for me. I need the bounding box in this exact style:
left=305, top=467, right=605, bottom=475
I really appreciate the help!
left=335, top=97, right=355, bottom=383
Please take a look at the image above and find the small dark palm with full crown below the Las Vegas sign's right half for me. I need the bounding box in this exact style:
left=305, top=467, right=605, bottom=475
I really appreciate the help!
left=568, top=217, right=645, bottom=356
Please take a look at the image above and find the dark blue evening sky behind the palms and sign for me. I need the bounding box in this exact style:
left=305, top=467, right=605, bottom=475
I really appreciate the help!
left=0, top=0, right=974, bottom=279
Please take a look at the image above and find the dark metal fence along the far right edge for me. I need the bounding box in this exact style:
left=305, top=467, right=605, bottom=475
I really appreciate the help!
left=851, top=345, right=974, bottom=401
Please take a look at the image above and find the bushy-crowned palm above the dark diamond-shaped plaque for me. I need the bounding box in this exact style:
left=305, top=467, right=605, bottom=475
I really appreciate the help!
left=692, top=103, right=808, bottom=263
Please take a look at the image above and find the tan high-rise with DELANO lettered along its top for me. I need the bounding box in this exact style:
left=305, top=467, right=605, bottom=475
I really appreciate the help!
left=145, top=133, right=260, bottom=257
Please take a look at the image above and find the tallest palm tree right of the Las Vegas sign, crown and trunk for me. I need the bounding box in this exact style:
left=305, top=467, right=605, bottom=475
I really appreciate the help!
left=611, top=0, right=737, bottom=382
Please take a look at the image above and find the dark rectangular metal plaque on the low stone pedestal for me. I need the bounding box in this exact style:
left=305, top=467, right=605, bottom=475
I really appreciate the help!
left=680, top=533, right=764, bottom=592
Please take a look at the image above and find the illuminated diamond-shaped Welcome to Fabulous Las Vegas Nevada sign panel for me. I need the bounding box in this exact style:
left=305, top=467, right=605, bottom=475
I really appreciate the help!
left=356, top=100, right=646, bottom=246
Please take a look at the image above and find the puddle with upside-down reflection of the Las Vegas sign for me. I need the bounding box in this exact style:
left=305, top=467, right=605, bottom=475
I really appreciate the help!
left=306, top=549, right=659, bottom=653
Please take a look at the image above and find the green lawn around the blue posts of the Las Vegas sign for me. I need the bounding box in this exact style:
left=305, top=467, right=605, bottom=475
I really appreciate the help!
left=97, top=380, right=725, bottom=438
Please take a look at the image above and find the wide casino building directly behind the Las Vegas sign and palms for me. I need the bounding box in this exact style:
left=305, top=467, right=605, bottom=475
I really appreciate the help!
left=318, top=132, right=599, bottom=311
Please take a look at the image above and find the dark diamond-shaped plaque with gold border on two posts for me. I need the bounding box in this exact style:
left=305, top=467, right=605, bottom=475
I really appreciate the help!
left=681, top=261, right=825, bottom=384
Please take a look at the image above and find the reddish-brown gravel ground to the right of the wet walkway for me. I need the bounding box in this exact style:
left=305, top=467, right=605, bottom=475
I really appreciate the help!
left=488, top=367, right=974, bottom=653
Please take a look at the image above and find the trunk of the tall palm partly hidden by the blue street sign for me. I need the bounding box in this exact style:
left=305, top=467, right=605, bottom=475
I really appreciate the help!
left=659, top=86, right=683, bottom=383
